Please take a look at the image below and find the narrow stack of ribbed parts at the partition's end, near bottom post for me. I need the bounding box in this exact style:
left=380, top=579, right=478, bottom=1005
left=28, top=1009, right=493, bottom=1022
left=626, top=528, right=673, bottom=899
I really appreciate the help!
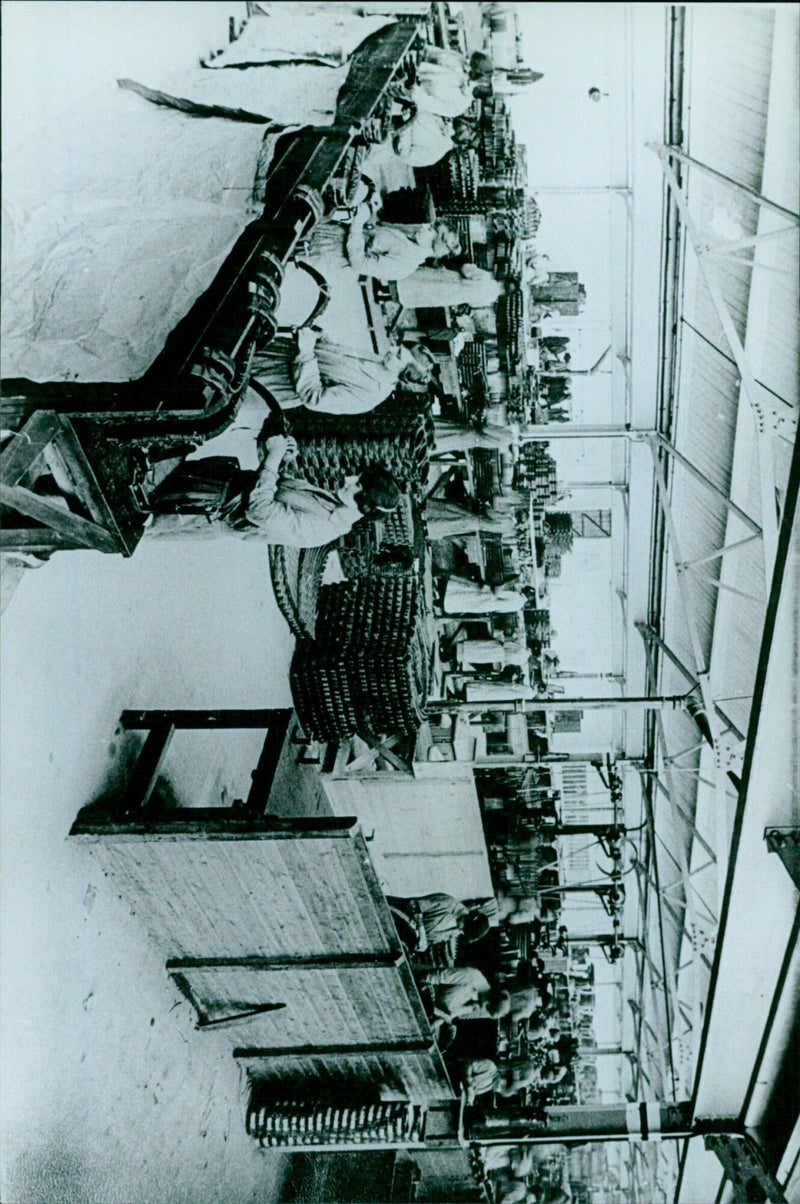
left=247, top=1099, right=425, bottom=1149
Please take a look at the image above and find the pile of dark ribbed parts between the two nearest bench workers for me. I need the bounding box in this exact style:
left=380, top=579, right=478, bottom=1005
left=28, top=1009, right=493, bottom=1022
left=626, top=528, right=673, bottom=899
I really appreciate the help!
left=292, top=390, right=434, bottom=498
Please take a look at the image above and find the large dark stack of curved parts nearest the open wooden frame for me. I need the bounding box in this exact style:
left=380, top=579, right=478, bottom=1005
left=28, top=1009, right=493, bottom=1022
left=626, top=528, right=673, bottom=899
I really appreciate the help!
left=289, top=576, right=430, bottom=740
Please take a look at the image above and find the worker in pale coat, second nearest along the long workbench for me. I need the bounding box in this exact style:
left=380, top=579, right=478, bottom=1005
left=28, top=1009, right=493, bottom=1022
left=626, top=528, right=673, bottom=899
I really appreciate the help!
left=251, top=327, right=434, bottom=414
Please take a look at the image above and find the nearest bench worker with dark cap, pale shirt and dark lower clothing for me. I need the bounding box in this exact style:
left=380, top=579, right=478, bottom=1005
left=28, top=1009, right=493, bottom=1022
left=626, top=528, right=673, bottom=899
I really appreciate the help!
left=145, top=435, right=401, bottom=548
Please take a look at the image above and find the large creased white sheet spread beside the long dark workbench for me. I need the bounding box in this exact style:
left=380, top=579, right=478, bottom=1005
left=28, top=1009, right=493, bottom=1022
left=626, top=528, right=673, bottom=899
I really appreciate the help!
left=0, top=69, right=330, bottom=380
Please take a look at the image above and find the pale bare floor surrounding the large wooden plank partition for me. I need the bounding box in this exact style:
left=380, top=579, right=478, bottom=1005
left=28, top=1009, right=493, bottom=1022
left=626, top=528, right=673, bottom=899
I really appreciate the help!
left=0, top=541, right=292, bottom=1204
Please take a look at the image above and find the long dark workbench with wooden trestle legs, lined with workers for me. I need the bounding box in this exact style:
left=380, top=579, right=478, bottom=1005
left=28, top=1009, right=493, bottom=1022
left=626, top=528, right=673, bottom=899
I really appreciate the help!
left=0, top=17, right=422, bottom=555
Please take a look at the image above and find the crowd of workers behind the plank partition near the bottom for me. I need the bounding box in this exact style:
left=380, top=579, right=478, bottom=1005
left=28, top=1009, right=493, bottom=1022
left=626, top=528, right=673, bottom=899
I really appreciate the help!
left=388, top=876, right=577, bottom=1204
